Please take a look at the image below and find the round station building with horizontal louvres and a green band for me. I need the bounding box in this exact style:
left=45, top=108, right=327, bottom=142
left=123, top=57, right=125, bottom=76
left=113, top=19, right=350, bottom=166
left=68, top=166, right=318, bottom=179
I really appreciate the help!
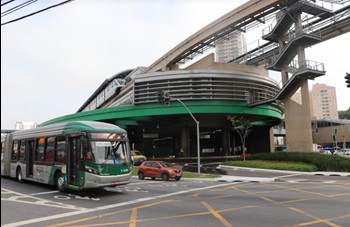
left=43, top=54, right=283, bottom=157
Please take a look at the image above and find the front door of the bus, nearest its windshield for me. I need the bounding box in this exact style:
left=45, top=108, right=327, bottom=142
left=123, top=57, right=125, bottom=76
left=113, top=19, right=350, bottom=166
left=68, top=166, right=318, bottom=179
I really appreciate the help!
left=67, top=137, right=81, bottom=186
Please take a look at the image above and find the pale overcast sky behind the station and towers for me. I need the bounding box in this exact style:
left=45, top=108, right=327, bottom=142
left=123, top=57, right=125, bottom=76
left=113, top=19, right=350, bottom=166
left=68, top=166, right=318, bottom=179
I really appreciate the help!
left=1, top=0, right=350, bottom=129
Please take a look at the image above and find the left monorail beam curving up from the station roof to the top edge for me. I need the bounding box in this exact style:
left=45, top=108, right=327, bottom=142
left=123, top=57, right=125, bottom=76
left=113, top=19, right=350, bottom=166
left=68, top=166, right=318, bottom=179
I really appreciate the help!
left=146, top=0, right=297, bottom=72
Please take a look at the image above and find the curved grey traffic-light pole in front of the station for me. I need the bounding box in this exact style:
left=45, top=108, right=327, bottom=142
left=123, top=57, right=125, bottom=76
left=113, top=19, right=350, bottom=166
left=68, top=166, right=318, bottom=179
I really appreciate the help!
left=157, top=90, right=201, bottom=175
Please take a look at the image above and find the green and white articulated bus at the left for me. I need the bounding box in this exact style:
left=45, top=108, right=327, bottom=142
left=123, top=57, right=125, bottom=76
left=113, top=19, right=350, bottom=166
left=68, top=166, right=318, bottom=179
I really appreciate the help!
left=1, top=121, right=133, bottom=192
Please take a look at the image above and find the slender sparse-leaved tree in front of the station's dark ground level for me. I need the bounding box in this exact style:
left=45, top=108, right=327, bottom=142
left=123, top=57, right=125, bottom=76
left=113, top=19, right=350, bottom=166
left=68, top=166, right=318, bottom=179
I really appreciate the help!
left=227, top=115, right=252, bottom=161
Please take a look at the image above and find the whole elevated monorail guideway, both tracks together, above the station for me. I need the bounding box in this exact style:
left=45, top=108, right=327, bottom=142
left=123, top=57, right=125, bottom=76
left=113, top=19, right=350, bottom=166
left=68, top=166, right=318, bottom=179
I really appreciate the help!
left=146, top=0, right=350, bottom=72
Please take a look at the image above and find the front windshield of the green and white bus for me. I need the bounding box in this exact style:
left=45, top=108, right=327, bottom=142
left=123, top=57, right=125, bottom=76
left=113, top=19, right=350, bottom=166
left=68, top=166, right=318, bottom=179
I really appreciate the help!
left=90, top=141, right=130, bottom=164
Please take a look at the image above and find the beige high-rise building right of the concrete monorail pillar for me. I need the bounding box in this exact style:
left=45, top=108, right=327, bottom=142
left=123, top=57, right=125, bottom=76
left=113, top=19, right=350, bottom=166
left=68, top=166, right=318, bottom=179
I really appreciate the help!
left=310, top=84, right=339, bottom=120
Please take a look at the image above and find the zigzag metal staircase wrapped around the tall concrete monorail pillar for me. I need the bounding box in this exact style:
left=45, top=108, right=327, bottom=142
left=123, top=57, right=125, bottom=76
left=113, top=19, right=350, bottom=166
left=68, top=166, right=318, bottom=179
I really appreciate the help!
left=248, top=0, right=332, bottom=107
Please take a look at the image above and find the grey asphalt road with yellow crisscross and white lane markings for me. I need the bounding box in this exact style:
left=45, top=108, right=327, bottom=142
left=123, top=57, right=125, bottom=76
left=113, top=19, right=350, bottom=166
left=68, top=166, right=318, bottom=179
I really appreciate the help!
left=1, top=167, right=350, bottom=227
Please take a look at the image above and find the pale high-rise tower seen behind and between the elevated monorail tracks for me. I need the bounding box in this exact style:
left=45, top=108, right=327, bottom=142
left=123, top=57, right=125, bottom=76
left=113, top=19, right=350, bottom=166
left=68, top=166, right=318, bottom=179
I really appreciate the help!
left=215, top=31, right=247, bottom=63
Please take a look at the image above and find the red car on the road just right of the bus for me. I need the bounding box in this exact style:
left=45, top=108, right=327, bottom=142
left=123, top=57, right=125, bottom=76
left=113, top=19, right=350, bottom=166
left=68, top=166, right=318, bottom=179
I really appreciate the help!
left=137, top=160, right=182, bottom=181
